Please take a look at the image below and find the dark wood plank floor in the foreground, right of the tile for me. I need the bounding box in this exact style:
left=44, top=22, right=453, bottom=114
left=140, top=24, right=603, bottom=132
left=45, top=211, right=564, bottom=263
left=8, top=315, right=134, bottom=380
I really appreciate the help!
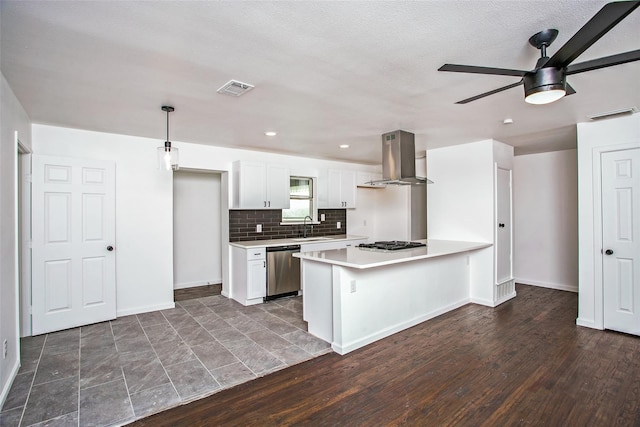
left=134, top=285, right=640, bottom=426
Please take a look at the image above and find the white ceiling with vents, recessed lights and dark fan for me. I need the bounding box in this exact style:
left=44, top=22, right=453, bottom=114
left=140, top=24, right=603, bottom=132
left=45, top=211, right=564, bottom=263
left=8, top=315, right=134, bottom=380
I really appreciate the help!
left=0, top=0, right=640, bottom=164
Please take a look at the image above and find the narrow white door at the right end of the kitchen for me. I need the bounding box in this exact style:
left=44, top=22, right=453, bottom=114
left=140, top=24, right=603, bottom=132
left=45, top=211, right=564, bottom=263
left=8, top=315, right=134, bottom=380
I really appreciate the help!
left=496, top=168, right=513, bottom=284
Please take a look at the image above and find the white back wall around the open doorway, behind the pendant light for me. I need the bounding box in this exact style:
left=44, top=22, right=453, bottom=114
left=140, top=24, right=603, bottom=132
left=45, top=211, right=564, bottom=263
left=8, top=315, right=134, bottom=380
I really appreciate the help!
left=33, top=125, right=376, bottom=316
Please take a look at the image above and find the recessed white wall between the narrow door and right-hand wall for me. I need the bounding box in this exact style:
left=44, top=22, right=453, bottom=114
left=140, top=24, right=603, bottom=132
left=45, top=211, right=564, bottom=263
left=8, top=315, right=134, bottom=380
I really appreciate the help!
left=513, top=150, right=578, bottom=292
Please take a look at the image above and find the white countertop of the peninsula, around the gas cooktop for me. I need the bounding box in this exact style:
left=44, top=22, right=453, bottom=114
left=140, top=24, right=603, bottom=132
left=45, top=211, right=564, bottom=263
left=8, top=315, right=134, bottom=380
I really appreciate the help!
left=293, top=239, right=492, bottom=269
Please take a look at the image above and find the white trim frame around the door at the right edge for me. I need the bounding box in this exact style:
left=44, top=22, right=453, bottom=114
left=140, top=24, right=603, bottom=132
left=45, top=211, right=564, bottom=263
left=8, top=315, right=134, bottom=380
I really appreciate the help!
left=592, top=142, right=640, bottom=329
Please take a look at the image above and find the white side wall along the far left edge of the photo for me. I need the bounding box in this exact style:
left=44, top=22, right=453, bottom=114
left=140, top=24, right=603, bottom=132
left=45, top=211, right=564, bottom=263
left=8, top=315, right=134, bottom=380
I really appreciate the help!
left=0, top=72, right=31, bottom=406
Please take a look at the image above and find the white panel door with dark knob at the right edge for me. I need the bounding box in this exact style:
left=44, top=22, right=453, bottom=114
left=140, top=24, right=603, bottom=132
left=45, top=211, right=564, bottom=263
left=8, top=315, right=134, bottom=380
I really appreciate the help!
left=601, top=148, right=640, bottom=335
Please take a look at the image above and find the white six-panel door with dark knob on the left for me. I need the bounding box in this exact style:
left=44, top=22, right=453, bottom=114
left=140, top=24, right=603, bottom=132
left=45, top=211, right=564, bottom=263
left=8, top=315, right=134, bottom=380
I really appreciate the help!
left=32, top=155, right=116, bottom=335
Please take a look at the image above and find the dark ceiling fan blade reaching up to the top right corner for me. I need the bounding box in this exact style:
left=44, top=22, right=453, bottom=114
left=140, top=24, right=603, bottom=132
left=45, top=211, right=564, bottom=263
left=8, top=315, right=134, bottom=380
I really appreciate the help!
left=544, top=1, right=640, bottom=68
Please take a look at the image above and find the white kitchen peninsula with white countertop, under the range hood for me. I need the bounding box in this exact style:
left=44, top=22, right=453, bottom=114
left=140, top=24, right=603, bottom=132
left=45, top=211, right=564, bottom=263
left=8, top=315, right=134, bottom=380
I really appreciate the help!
left=294, top=240, right=491, bottom=354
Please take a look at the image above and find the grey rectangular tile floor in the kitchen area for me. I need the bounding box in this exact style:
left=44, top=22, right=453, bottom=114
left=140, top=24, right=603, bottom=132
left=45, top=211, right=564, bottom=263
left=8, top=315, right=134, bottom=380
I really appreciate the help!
left=0, top=295, right=331, bottom=427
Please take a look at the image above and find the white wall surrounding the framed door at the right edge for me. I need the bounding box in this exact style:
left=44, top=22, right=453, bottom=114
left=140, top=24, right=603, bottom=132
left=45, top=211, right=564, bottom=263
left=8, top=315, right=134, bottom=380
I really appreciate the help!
left=576, top=114, right=640, bottom=329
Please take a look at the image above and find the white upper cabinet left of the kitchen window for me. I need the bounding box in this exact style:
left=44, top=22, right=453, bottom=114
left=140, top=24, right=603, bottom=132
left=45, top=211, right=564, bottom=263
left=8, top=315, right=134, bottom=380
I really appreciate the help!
left=233, top=161, right=289, bottom=209
